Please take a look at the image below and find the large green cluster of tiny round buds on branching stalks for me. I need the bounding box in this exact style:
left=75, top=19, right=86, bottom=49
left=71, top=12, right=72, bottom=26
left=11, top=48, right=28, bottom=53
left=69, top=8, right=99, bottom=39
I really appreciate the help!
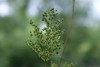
left=27, top=8, right=63, bottom=61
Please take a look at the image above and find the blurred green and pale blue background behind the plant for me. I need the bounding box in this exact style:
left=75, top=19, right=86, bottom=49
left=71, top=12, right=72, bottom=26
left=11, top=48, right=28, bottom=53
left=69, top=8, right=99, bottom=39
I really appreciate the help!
left=0, top=0, right=100, bottom=67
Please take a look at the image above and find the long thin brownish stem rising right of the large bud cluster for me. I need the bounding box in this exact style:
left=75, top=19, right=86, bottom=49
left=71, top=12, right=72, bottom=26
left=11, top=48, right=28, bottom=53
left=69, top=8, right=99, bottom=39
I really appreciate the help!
left=58, top=0, right=75, bottom=67
